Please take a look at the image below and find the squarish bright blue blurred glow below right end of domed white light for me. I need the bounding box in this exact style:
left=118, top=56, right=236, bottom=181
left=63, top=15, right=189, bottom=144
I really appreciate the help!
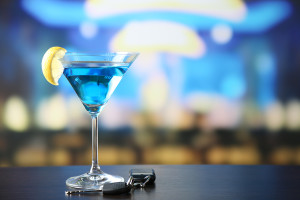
left=183, top=53, right=246, bottom=99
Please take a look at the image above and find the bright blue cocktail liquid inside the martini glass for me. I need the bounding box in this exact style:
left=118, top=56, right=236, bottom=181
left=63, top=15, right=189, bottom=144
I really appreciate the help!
left=64, top=62, right=128, bottom=113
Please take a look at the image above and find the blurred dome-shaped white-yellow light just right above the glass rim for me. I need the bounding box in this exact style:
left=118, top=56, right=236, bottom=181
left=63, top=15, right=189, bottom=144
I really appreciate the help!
left=110, top=21, right=205, bottom=57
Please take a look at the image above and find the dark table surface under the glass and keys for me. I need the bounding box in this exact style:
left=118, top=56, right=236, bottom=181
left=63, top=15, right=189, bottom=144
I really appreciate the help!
left=0, top=165, right=300, bottom=200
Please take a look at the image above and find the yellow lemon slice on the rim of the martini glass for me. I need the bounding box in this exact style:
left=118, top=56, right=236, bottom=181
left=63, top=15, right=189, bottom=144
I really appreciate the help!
left=42, top=47, right=67, bottom=85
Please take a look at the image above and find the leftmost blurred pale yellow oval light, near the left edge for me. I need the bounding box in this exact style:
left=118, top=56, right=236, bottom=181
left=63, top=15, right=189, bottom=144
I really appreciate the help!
left=3, top=96, right=30, bottom=132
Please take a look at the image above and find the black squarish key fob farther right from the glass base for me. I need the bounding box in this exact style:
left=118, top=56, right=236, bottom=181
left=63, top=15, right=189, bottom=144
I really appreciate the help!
left=129, top=168, right=156, bottom=184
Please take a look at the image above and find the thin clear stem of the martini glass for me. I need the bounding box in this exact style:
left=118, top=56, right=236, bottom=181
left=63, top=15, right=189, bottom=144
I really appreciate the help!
left=90, top=114, right=101, bottom=174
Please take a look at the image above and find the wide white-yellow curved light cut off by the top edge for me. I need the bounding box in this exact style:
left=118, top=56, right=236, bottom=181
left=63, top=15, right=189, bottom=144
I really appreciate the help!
left=85, top=0, right=247, bottom=22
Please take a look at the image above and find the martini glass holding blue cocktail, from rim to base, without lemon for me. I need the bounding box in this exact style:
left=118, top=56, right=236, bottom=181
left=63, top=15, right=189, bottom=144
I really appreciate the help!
left=62, top=52, right=138, bottom=190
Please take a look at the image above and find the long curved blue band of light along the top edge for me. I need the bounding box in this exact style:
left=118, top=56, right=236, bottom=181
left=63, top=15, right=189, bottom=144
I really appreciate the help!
left=22, top=0, right=292, bottom=32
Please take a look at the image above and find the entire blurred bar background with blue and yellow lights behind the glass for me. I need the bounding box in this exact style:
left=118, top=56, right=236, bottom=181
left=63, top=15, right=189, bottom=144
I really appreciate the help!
left=0, top=0, right=300, bottom=167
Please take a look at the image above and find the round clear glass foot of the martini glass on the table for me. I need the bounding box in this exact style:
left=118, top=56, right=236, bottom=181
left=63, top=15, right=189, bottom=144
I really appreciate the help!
left=66, top=171, right=124, bottom=190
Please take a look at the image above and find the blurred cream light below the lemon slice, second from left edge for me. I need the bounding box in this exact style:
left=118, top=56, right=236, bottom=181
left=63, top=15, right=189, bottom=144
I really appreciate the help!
left=36, top=94, right=68, bottom=130
